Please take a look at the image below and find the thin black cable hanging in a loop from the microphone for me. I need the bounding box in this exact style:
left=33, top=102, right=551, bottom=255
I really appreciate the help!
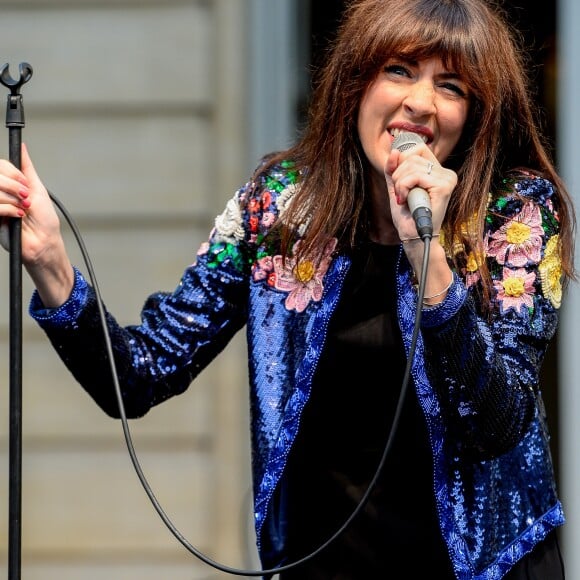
left=48, top=191, right=431, bottom=576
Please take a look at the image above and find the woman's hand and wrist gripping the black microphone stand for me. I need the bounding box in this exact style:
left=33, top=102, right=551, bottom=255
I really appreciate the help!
left=0, top=145, right=74, bottom=308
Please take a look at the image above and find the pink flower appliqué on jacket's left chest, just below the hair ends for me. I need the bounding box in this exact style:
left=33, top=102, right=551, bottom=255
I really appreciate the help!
left=274, top=238, right=337, bottom=312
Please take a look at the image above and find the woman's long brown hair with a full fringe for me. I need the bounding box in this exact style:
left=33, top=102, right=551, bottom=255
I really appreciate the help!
left=258, top=0, right=575, bottom=295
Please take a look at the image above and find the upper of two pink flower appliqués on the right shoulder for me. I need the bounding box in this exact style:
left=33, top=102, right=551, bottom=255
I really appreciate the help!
left=487, top=202, right=544, bottom=267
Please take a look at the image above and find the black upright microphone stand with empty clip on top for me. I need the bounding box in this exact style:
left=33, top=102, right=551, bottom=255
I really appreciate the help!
left=0, top=62, right=32, bottom=580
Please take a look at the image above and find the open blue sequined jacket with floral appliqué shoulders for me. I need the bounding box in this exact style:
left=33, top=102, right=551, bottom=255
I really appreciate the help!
left=30, top=164, right=564, bottom=580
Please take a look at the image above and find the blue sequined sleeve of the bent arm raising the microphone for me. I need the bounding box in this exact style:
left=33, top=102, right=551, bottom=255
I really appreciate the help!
left=422, top=177, right=562, bottom=457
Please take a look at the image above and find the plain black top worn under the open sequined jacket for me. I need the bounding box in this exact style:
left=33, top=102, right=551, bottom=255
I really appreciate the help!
left=280, top=243, right=454, bottom=580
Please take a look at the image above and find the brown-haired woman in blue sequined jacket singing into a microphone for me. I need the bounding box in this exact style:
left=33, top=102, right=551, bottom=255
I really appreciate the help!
left=0, top=0, right=575, bottom=580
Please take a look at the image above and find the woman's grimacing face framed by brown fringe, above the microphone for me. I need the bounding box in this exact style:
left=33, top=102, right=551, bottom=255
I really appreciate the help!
left=358, top=58, right=470, bottom=185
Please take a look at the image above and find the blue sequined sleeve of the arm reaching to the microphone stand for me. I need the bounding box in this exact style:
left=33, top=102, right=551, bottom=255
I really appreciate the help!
left=29, top=184, right=251, bottom=417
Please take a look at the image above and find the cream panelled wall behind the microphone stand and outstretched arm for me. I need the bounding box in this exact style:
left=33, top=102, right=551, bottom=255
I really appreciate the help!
left=0, top=0, right=262, bottom=580
